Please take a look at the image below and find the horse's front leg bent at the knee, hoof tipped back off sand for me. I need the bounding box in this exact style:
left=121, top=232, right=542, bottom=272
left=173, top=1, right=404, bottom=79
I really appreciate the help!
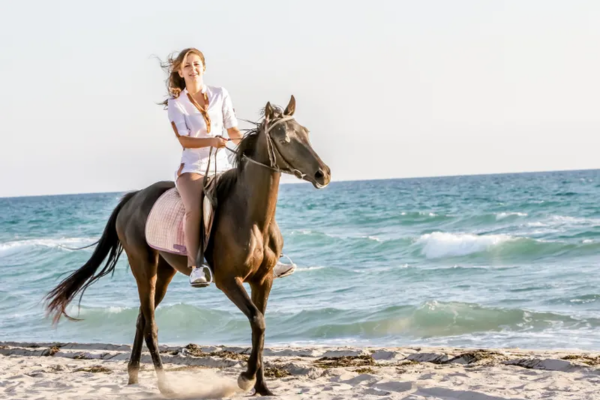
left=216, top=278, right=265, bottom=391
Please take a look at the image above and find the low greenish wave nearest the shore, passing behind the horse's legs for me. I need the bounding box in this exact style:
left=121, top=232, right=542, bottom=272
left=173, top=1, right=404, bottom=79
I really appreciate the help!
left=50, top=301, right=600, bottom=342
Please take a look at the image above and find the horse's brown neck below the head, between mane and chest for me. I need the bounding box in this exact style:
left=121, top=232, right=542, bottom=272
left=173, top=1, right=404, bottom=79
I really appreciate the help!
left=240, top=163, right=281, bottom=233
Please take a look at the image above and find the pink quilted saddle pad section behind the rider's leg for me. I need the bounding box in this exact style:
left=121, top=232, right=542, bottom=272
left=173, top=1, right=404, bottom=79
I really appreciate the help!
left=146, top=188, right=187, bottom=255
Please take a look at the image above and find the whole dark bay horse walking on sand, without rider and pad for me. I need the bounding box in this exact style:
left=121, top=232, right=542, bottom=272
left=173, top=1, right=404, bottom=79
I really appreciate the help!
left=47, top=96, right=331, bottom=395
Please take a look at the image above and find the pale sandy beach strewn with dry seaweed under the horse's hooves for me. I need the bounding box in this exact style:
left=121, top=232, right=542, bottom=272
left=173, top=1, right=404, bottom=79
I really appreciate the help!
left=0, top=342, right=600, bottom=400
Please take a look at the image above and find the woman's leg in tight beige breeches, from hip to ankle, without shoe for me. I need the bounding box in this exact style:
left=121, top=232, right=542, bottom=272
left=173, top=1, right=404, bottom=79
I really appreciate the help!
left=177, top=172, right=204, bottom=267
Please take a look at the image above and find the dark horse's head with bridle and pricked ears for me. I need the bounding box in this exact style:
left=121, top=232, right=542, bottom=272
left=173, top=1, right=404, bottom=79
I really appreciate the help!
left=260, top=96, right=331, bottom=189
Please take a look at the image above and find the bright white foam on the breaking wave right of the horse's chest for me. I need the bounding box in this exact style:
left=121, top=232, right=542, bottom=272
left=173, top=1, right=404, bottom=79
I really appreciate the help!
left=416, top=232, right=514, bottom=258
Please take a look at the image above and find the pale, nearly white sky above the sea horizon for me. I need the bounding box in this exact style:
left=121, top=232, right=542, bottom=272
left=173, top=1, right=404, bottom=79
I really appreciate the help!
left=0, top=0, right=600, bottom=197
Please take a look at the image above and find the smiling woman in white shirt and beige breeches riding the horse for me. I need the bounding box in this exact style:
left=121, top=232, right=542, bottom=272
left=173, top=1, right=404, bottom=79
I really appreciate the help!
left=164, top=48, right=295, bottom=287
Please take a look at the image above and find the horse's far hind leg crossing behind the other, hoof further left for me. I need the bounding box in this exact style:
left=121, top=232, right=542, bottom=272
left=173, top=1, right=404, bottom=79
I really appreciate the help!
left=127, top=257, right=177, bottom=385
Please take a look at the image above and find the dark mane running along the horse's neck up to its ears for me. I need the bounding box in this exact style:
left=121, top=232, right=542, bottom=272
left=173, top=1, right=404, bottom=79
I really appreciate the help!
left=217, top=106, right=283, bottom=201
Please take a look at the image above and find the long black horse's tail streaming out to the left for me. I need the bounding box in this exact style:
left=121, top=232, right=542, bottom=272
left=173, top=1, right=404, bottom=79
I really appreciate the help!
left=45, top=192, right=137, bottom=324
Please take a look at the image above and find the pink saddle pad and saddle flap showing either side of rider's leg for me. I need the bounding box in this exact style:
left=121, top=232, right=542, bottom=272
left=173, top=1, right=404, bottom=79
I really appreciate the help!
left=146, top=174, right=220, bottom=256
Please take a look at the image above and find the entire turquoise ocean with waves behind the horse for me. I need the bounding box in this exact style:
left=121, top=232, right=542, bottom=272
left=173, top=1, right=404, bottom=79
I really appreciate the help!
left=0, top=170, right=600, bottom=350
